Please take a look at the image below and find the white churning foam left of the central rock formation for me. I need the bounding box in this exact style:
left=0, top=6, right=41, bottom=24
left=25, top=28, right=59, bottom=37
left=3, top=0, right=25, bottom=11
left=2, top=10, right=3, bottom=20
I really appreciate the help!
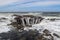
left=0, top=15, right=13, bottom=33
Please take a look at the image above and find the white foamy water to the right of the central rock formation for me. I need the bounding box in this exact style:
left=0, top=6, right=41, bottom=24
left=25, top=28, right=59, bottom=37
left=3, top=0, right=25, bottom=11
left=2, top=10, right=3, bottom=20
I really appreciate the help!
left=25, top=17, right=60, bottom=40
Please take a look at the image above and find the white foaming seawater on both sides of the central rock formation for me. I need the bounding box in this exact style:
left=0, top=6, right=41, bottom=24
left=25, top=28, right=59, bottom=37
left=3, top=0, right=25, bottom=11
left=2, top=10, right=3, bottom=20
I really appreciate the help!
left=0, top=13, right=60, bottom=40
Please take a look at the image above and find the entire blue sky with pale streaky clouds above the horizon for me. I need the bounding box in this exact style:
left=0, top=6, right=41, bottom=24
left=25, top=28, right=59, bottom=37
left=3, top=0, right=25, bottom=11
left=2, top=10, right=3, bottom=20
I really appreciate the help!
left=0, top=0, right=60, bottom=12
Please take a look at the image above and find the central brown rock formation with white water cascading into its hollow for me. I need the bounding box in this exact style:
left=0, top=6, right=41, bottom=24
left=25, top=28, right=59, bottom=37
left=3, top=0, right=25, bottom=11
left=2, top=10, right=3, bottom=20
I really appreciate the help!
left=11, top=15, right=44, bottom=29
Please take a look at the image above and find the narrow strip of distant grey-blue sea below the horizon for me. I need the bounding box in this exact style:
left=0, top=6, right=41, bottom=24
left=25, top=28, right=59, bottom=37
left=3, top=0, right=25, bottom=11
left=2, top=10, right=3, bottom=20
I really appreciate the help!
left=0, top=12, right=60, bottom=17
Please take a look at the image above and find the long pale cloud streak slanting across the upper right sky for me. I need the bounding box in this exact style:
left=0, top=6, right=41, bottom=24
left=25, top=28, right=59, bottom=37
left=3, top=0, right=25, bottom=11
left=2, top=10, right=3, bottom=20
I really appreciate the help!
left=20, top=1, right=60, bottom=7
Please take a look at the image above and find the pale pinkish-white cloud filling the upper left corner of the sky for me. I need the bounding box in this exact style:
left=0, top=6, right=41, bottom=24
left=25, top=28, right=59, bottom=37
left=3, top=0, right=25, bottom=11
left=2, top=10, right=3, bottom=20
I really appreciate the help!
left=0, top=0, right=38, bottom=6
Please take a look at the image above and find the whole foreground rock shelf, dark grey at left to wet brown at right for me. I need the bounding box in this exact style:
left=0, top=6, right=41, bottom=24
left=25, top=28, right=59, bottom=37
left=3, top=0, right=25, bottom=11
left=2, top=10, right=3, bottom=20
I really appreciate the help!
left=0, top=30, right=54, bottom=40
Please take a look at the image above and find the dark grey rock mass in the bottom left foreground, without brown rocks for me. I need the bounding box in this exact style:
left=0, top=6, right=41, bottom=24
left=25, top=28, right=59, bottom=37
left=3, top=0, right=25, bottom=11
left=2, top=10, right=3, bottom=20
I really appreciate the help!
left=0, top=30, right=38, bottom=40
